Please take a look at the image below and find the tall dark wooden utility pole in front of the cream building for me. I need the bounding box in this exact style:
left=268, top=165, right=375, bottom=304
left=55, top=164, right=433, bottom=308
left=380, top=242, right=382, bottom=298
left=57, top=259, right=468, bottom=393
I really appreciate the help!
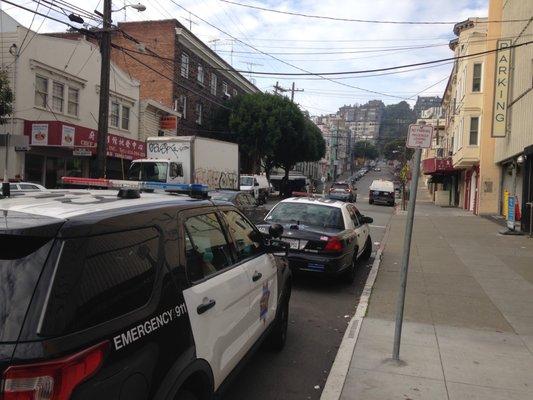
left=94, top=0, right=111, bottom=178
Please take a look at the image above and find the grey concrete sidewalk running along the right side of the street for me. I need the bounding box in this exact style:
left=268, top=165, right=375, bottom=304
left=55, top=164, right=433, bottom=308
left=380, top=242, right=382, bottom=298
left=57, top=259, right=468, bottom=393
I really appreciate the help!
left=341, top=190, right=533, bottom=400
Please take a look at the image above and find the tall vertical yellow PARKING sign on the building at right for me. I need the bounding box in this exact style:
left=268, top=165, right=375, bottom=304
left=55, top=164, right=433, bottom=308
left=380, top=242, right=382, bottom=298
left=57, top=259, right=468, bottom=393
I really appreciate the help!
left=492, top=39, right=511, bottom=137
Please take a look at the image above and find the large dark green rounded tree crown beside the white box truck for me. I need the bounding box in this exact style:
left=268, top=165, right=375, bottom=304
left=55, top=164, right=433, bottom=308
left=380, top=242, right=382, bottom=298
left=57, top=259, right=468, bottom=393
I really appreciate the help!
left=216, top=93, right=326, bottom=175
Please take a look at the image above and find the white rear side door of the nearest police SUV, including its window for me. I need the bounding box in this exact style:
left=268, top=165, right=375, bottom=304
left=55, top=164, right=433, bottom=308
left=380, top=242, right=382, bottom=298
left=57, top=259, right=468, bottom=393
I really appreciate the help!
left=180, top=210, right=251, bottom=389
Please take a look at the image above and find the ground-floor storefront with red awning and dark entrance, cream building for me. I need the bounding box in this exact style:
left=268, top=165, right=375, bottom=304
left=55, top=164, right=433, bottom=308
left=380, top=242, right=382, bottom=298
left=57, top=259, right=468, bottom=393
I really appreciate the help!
left=23, top=121, right=146, bottom=188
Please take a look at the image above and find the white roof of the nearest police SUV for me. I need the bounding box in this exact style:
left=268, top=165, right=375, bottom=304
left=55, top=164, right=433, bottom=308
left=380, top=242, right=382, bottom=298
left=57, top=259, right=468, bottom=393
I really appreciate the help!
left=0, top=189, right=213, bottom=220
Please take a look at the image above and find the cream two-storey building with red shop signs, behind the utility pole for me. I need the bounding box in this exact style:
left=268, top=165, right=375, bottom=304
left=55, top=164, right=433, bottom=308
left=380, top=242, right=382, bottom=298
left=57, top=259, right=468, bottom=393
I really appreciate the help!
left=0, top=14, right=179, bottom=188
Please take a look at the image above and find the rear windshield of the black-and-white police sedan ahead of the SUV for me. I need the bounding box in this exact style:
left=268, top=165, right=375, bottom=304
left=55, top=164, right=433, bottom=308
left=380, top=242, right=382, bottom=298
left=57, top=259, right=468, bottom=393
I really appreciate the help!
left=266, top=202, right=344, bottom=229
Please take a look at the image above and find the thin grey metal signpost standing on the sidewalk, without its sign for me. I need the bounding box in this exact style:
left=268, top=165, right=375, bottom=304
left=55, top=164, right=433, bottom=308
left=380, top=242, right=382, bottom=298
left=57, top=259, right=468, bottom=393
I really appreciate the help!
left=392, top=148, right=422, bottom=361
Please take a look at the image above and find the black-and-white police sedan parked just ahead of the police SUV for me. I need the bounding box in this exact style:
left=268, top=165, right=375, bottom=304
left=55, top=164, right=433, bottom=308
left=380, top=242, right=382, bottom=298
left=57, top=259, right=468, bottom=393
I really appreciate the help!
left=258, top=197, right=373, bottom=282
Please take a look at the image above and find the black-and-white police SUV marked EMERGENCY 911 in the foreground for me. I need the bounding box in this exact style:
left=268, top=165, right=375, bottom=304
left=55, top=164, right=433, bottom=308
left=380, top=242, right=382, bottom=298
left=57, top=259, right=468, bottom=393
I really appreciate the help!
left=0, top=189, right=291, bottom=400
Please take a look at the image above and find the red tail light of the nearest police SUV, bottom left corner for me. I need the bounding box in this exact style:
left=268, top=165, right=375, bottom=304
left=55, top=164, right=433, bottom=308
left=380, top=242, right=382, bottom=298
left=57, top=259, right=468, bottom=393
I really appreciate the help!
left=0, top=342, right=109, bottom=400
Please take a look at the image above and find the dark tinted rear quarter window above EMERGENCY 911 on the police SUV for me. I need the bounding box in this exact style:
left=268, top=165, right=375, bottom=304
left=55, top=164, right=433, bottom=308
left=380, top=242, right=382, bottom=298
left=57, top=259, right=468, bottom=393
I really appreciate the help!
left=41, top=228, right=159, bottom=335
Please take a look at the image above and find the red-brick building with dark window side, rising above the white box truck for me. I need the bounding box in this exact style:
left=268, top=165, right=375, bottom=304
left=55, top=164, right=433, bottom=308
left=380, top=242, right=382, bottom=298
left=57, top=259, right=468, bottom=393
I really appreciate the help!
left=112, top=19, right=259, bottom=135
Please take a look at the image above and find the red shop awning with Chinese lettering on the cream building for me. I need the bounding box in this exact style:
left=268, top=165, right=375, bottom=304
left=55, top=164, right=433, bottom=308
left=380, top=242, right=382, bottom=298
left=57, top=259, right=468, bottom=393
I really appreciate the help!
left=24, top=121, right=146, bottom=160
